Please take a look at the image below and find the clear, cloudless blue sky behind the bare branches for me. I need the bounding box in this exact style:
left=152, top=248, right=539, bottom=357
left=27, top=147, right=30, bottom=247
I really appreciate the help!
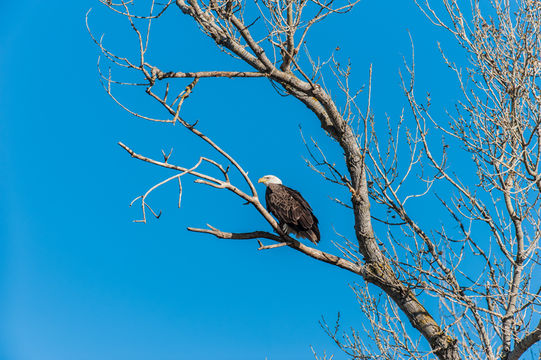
left=0, top=0, right=462, bottom=360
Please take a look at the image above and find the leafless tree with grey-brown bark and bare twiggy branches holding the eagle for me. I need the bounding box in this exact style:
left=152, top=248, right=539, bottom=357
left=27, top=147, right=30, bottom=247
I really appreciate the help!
left=87, top=0, right=541, bottom=360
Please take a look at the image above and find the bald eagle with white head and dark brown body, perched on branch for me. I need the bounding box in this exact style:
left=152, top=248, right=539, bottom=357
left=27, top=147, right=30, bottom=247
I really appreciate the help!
left=258, top=175, right=320, bottom=245
